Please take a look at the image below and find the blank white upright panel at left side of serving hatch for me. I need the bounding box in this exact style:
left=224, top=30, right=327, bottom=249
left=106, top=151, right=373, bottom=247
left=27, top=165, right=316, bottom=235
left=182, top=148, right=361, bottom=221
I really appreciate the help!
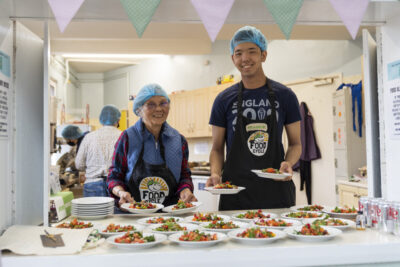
left=15, top=23, right=44, bottom=225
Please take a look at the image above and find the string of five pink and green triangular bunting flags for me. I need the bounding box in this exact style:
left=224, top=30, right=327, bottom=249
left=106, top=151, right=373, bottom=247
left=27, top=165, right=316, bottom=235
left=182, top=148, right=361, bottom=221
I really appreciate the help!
left=47, top=0, right=369, bottom=42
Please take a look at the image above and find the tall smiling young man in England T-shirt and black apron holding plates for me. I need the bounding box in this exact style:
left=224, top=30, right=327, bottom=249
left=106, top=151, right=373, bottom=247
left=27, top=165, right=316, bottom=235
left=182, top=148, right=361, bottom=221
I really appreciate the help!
left=207, top=26, right=301, bottom=210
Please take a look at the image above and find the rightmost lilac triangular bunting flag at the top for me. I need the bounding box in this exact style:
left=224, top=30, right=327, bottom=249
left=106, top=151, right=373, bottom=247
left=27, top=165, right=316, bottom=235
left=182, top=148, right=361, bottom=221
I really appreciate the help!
left=329, top=0, right=369, bottom=40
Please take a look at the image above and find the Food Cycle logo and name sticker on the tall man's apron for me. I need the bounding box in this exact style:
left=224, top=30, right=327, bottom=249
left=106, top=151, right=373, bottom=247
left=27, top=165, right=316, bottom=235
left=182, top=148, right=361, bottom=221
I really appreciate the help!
left=246, top=123, right=269, bottom=156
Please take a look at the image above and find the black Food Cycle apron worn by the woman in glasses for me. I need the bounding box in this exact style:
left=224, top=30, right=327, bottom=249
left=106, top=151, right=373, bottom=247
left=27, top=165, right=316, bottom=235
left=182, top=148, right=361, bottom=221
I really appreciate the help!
left=128, top=125, right=179, bottom=206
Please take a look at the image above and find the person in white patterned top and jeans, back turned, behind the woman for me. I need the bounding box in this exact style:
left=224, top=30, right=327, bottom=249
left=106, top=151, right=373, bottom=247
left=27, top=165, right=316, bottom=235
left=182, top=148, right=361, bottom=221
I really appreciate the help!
left=75, top=105, right=121, bottom=197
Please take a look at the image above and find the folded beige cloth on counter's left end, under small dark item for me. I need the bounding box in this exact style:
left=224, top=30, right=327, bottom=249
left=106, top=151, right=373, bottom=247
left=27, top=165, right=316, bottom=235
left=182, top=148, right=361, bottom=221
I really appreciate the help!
left=0, top=225, right=93, bottom=255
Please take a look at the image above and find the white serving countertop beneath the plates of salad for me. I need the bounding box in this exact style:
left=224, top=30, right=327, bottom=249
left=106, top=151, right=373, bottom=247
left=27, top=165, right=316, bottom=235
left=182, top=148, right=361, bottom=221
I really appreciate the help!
left=1, top=210, right=400, bottom=267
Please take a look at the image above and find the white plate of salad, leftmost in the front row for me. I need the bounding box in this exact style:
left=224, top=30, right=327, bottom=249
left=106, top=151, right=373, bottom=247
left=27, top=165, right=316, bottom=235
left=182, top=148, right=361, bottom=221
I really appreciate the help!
left=107, top=231, right=167, bottom=250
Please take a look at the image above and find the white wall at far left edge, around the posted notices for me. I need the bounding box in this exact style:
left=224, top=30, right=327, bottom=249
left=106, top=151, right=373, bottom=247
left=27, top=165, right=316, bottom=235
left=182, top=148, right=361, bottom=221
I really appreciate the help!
left=0, top=21, right=15, bottom=233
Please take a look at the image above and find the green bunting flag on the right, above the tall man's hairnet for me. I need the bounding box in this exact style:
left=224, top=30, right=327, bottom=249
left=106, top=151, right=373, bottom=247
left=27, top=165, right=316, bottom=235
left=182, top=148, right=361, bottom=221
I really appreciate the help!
left=264, top=0, right=303, bottom=39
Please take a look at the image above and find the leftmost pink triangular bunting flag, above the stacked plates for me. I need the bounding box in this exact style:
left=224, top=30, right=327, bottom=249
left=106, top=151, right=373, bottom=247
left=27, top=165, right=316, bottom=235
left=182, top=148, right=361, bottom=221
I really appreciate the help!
left=48, top=0, right=85, bottom=32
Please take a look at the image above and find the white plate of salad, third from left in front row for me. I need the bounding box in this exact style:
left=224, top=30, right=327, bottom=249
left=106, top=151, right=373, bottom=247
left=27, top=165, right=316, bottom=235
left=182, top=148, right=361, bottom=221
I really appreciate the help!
left=228, top=227, right=286, bottom=245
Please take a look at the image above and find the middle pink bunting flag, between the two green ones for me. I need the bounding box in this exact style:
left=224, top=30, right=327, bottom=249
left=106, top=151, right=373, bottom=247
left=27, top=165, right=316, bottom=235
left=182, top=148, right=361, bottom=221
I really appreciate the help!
left=190, top=0, right=235, bottom=42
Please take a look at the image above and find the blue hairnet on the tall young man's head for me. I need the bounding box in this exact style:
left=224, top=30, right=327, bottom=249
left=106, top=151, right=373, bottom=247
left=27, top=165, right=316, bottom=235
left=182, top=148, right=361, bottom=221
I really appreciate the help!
left=230, top=26, right=267, bottom=55
